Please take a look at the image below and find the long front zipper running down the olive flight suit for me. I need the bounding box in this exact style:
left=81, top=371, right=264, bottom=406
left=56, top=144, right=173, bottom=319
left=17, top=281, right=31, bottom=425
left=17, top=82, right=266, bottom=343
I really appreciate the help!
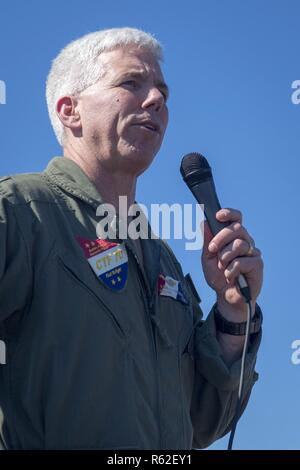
left=126, top=244, right=165, bottom=449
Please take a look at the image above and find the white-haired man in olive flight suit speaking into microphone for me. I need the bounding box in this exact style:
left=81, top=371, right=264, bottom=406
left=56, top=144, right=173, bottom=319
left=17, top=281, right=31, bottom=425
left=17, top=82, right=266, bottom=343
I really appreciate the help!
left=0, top=28, right=262, bottom=449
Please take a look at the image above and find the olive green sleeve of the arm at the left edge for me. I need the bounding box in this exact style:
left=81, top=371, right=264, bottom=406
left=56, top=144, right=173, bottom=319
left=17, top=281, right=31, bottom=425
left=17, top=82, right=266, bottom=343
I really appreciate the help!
left=0, top=187, right=31, bottom=326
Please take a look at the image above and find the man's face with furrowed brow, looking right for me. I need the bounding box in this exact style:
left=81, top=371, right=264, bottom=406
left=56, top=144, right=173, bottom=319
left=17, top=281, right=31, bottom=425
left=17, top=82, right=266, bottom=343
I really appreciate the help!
left=78, top=46, right=168, bottom=174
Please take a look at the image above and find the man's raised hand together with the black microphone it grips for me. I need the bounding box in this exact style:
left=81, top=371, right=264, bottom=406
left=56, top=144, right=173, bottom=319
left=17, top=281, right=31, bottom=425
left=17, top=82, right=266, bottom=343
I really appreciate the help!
left=180, top=153, right=263, bottom=322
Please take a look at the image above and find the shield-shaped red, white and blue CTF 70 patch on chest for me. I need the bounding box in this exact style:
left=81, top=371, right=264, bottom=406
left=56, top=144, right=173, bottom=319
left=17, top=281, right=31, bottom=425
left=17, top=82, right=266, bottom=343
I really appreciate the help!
left=76, top=237, right=128, bottom=290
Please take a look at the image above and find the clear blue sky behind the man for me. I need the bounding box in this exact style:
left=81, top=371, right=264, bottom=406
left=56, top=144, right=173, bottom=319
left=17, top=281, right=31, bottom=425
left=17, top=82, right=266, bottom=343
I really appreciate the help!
left=0, top=0, right=300, bottom=449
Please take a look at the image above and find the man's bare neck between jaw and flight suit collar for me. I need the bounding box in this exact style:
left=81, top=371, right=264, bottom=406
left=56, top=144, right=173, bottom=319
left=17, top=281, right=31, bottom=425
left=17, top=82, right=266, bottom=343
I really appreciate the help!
left=64, top=140, right=137, bottom=208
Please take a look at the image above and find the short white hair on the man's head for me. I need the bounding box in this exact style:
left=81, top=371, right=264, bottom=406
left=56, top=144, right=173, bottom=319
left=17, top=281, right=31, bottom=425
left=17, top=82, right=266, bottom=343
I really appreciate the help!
left=46, top=28, right=163, bottom=145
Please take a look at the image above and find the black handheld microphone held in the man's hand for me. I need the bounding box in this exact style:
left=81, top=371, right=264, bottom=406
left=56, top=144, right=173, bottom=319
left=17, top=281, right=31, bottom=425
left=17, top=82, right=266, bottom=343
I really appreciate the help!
left=180, top=152, right=251, bottom=302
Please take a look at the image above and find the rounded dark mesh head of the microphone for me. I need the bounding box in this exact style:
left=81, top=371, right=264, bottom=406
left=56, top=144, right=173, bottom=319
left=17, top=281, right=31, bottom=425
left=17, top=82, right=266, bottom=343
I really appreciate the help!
left=180, top=152, right=212, bottom=187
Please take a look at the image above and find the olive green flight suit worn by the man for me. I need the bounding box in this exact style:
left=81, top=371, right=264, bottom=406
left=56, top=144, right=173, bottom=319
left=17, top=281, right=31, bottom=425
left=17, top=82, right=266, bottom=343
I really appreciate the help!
left=0, top=157, right=260, bottom=449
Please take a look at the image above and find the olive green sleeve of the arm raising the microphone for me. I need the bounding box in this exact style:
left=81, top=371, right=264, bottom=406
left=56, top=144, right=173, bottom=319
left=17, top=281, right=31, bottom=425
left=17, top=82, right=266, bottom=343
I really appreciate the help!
left=191, top=302, right=261, bottom=448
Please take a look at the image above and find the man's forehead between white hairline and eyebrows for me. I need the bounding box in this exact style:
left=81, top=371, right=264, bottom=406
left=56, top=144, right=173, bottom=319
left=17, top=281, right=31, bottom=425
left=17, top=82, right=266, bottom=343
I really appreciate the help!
left=100, top=46, right=163, bottom=79
